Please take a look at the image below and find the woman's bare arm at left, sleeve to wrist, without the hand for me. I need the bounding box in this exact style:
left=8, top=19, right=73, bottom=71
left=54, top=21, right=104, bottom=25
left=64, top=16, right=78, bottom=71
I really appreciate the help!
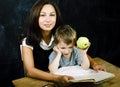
left=22, top=46, right=54, bottom=80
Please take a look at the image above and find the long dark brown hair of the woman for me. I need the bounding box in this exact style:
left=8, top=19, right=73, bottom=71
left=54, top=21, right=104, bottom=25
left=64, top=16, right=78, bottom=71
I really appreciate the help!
left=24, top=0, right=61, bottom=46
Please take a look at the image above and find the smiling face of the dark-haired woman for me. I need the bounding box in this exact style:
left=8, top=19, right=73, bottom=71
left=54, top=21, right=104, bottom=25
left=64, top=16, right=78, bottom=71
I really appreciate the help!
left=38, top=4, right=56, bottom=31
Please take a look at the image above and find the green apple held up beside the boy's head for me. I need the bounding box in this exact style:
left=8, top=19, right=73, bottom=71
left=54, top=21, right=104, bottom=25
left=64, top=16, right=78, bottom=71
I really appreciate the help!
left=77, top=36, right=90, bottom=49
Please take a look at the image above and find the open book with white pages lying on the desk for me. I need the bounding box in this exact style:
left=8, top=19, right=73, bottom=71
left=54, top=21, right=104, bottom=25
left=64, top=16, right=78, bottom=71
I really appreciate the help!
left=54, top=66, right=115, bottom=84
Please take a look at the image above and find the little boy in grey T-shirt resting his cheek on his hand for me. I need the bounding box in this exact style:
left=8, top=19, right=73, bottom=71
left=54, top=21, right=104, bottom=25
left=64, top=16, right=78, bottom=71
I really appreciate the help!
left=48, top=25, right=90, bottom=73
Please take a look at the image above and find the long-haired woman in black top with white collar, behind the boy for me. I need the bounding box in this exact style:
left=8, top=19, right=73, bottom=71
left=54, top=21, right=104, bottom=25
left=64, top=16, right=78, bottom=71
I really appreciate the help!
left=22, top=0, right=105, bottom=83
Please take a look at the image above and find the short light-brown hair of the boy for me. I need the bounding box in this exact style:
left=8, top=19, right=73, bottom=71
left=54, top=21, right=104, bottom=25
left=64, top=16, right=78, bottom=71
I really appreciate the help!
left=54, top=25, right=77, bottom=45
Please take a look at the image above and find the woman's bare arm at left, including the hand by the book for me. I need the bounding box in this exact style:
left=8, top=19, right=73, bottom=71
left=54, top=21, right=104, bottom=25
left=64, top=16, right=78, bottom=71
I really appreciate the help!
left=22, top=46, right=73, bottom=83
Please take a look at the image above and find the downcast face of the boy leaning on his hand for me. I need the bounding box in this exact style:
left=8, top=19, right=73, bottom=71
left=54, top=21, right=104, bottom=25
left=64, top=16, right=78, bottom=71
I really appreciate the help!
left=57, top=41, right=74, bottom=58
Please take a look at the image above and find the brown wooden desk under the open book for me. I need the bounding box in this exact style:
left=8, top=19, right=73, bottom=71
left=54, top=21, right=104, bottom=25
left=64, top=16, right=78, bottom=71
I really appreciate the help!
left=13, top=58, right=120, bottom=87
